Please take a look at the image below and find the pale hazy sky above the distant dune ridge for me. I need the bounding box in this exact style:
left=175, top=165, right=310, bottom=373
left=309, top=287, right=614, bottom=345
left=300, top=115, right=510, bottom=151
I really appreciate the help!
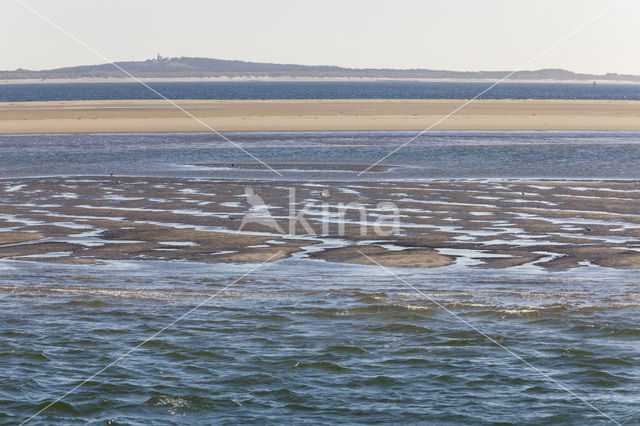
left=0, top=0, right=640, bottom=74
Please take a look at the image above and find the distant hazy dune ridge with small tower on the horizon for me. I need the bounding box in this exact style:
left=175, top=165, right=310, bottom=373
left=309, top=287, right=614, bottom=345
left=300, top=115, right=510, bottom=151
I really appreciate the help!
left=0, top=55, right=640, bottom=83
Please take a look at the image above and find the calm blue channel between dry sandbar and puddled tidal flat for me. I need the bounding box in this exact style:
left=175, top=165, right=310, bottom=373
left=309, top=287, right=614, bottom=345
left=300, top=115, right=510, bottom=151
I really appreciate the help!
left=0, top=131, right=640, bottom=181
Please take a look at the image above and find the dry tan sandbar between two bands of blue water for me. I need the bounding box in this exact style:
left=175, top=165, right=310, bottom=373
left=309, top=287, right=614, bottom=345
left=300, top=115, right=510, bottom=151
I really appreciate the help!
left=0, top=99, right=640, bottom=134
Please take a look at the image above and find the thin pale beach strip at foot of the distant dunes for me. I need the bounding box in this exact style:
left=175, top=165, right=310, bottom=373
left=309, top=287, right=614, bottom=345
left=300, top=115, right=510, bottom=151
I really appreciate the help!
left=0, top=76, right=640, bottom=85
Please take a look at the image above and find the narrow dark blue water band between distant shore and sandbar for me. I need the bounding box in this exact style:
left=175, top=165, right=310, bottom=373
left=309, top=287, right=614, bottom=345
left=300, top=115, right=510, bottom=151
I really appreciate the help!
left=0, top=81, right=640, bottom=102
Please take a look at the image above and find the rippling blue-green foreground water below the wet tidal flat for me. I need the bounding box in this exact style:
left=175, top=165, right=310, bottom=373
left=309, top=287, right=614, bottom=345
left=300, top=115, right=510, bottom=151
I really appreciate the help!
left=0, top=261, right=640, bottom=424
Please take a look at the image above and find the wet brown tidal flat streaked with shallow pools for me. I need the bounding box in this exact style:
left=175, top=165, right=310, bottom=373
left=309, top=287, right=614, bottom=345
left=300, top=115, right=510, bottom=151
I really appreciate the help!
left=0, top=176, right=640, bottom=270
